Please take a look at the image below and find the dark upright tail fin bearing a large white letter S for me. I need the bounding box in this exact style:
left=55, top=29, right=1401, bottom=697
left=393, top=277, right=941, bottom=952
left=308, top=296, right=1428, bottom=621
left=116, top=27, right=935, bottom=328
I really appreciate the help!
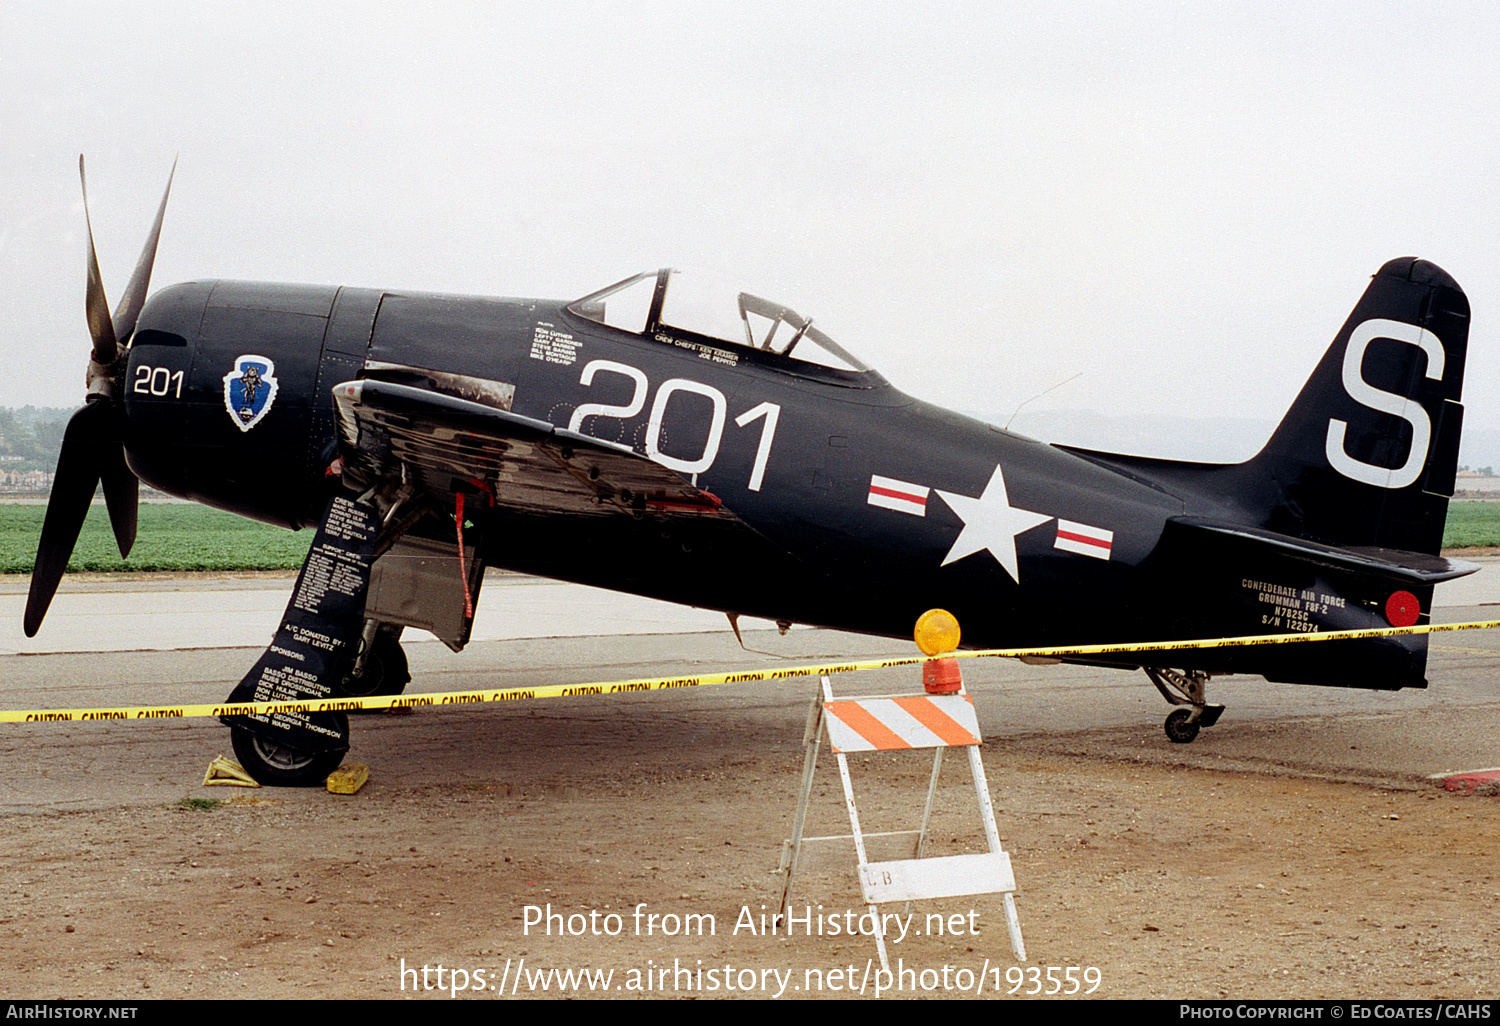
left=1236, top=257, right=1469, bottom=555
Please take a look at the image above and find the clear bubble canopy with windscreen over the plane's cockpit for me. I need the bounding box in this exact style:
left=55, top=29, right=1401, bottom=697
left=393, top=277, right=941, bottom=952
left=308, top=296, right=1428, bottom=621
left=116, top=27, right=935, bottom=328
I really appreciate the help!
left=567, top=267, right=870, bottom=374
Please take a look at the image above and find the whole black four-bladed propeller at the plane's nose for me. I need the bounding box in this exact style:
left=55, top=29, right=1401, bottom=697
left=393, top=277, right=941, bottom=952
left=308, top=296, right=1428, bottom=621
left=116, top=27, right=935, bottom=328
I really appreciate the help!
left=26, top=155, right=177, bottom=638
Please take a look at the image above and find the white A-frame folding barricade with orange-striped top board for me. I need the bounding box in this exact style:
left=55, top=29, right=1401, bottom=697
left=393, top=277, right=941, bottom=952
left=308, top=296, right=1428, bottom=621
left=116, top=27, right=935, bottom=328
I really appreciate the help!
left=780, top=675, right=1026, bottom=969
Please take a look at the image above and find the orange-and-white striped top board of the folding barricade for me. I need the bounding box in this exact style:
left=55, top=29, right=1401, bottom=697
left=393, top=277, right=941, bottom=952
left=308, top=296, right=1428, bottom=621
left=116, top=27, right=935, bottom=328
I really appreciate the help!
left=824, top=695, right=980, bottom=752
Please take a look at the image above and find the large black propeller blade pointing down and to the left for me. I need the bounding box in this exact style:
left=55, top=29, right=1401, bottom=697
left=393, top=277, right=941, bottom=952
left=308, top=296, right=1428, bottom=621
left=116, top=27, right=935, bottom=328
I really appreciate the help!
left=24, top=402, right=114, bottom=638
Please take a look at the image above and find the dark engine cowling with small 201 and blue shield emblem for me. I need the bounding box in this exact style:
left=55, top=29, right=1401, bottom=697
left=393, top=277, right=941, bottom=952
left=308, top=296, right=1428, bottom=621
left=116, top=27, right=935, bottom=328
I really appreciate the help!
left=117, top=281, right=381, bottom=527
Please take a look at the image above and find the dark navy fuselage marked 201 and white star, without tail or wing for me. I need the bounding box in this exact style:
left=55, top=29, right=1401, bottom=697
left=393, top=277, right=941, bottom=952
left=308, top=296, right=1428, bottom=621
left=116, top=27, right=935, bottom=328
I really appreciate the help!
left=117, top=282, right=1419, bottom=690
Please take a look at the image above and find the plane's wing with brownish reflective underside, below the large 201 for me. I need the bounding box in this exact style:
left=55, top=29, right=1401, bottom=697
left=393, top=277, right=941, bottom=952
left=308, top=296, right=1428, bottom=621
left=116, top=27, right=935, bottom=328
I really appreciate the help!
left=333, top=380, right=737, bottom=519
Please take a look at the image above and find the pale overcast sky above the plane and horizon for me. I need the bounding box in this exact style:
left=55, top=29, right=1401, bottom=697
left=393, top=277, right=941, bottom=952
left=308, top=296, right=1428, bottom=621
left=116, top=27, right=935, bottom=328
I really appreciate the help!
left=0, top=0, right=1500, bottom=450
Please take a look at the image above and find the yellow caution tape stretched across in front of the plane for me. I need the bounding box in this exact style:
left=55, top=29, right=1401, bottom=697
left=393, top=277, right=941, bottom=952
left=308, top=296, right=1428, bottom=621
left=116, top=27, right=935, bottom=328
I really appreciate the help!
left=0, top=620, right=1500, bottom=723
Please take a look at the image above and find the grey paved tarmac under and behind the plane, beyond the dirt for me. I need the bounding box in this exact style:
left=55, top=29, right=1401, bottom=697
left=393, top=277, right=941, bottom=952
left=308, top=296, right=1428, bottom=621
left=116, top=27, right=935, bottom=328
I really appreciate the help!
left=0, top=560, right=1500, bottom=813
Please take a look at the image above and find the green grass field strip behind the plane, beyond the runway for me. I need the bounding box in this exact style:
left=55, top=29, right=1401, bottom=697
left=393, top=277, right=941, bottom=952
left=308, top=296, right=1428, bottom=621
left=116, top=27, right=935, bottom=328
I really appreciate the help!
left=0, top=492, right=1500, bottom=573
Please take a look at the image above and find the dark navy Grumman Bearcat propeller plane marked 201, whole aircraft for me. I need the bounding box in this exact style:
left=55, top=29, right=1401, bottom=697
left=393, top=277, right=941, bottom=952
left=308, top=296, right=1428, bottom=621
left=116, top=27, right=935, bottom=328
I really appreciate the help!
left=26, top=162, right=1476, bottom=785
